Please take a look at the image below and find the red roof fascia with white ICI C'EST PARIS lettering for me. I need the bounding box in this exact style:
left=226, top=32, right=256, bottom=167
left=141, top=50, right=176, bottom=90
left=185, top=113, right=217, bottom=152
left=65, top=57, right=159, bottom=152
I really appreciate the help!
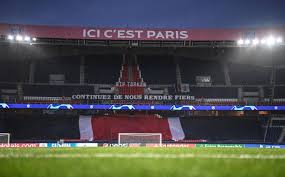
left=0, top=24, right=285, bottom=41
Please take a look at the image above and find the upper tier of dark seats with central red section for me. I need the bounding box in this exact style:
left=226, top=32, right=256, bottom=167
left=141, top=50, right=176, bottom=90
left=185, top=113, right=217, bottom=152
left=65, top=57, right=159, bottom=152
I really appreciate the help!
left=0, top=54, right=285, bottom=105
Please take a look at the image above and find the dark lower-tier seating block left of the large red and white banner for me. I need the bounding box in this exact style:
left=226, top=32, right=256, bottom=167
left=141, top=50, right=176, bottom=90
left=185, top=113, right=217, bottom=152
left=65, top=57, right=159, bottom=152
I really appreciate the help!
left=0, top=114, right=79, bottom=142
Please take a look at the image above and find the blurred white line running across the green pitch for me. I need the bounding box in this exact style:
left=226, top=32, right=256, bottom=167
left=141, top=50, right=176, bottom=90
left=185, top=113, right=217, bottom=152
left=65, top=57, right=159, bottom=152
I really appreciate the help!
left=0, top=153, right=285, bottom=159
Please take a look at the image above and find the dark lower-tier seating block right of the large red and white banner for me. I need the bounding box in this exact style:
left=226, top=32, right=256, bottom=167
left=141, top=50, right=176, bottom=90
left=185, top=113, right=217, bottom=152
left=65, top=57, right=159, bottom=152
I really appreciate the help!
left=181, top=117, right=263, bottom=142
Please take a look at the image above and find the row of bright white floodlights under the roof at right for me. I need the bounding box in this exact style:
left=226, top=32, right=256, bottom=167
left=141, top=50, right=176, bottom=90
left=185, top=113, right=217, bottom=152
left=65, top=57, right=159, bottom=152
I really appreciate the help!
left=237, top=35, right=284, bottom=47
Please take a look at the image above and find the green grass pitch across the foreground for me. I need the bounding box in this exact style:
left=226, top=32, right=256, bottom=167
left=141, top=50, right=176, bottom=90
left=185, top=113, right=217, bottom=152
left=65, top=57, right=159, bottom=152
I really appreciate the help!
left=0, top=147, right=285, bottom=177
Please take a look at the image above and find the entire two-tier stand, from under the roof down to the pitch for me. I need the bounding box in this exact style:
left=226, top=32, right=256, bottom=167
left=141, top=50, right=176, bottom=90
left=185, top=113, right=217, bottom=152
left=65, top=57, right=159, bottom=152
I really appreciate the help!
left=0, top=23, right=285, bottom=148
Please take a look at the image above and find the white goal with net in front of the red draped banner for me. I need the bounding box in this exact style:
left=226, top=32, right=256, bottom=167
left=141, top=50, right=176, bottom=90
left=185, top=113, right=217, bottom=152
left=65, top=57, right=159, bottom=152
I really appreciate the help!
left=118, top=133, right=162, bottom=145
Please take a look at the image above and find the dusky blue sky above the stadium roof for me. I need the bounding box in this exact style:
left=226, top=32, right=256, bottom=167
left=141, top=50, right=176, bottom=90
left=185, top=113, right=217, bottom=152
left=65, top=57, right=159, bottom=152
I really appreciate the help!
left=0, top=0, right=285, bottom=28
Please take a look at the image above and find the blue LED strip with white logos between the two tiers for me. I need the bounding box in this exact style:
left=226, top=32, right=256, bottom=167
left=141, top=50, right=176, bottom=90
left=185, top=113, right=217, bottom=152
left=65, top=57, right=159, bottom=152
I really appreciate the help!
left=0, top=103, right=285, bottom=111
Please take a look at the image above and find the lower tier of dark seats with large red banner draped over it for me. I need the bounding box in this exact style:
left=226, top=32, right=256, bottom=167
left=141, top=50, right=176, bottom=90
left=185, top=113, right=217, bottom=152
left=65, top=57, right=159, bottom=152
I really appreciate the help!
left=0, top=114, right=266, bottom=143
